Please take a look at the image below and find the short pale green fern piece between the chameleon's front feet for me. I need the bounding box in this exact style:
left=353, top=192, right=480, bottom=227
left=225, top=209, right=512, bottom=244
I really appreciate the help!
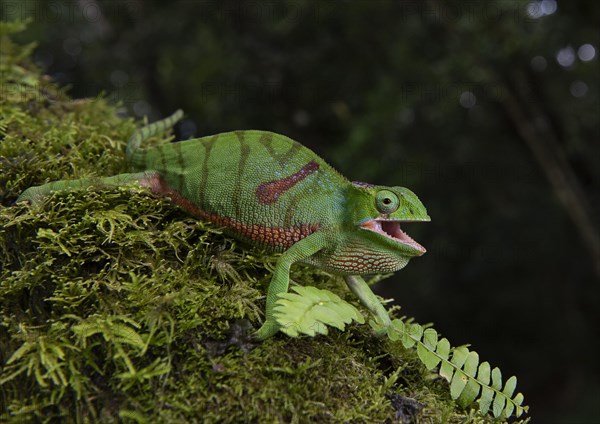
left=273, top=286, right=365, bottom=337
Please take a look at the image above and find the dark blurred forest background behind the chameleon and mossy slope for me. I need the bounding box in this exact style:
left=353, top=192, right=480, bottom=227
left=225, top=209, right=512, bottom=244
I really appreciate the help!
left=0, top=0, right=600, bottom=423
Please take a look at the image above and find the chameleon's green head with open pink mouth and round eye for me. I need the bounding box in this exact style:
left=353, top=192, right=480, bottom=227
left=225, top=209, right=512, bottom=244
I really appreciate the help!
left=353, top=182, right=431, bottom=257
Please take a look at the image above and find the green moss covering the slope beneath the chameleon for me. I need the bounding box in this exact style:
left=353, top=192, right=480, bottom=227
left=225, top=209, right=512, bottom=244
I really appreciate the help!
left=0, top=24, right=516, bottom=423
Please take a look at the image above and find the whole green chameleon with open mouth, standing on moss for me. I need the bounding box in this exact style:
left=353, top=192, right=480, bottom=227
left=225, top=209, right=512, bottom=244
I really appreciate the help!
left=17, top=110, right=430, bottom=340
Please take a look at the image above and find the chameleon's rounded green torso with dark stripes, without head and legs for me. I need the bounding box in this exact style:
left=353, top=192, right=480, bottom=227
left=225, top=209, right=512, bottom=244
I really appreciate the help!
left=130, top=131, right=350, bottom=251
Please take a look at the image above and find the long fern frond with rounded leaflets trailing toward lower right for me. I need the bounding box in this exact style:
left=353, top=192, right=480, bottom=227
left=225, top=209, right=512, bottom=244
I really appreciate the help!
left=370, top=319, right=528, bottom=419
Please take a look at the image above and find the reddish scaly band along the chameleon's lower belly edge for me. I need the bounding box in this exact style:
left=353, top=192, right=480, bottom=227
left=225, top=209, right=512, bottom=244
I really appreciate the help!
left=140, top=173, right=319, bottom=249
